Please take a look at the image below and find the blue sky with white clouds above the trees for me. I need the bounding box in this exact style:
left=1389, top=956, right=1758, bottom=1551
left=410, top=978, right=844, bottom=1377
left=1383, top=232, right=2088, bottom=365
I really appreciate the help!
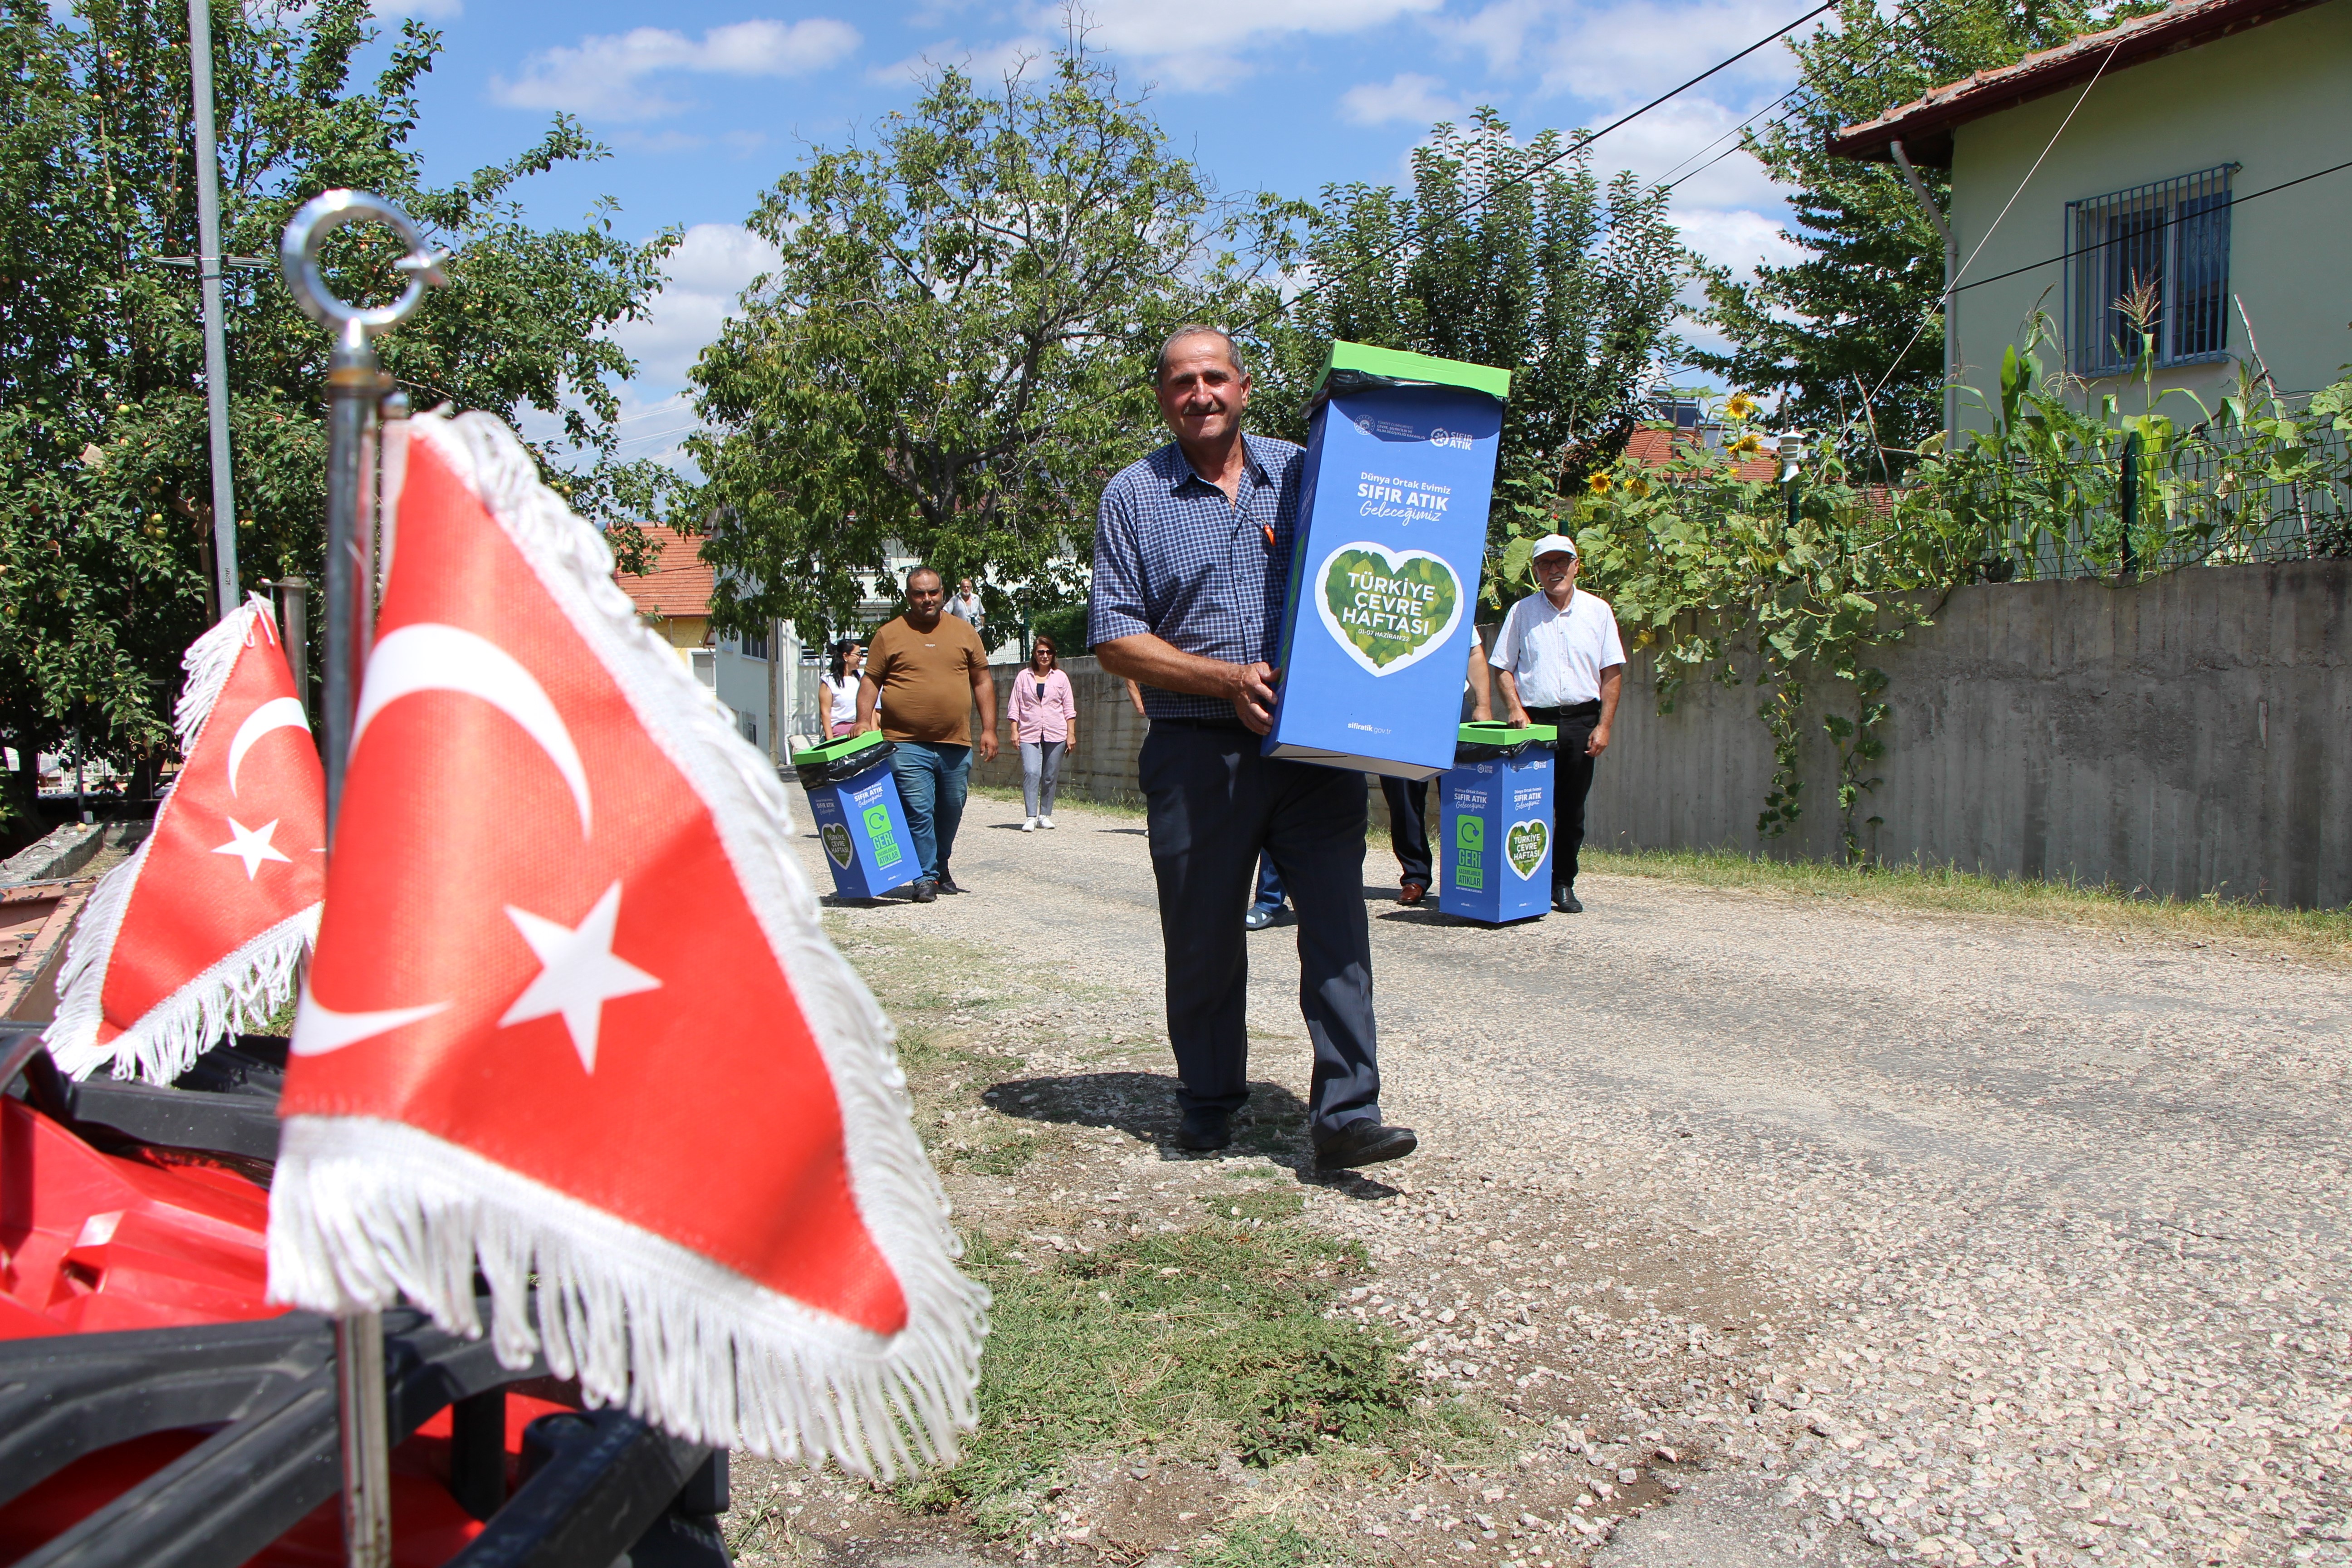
left=379, top=0, right=1808, bottom=456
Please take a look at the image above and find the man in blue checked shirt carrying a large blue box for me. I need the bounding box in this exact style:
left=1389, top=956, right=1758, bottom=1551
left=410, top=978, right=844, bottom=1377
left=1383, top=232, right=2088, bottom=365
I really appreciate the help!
left=1087, top=327, right=1416, bottom=1166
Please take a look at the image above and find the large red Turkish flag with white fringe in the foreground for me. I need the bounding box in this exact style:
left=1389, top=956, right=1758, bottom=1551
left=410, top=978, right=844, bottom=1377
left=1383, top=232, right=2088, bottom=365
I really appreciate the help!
left=270, top=414, right=985, bottom=1474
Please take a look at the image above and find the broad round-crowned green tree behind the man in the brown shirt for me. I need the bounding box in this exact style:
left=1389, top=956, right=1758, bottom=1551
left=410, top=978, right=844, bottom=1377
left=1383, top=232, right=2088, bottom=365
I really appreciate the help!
left=687, top=42, right=1289, bottom=635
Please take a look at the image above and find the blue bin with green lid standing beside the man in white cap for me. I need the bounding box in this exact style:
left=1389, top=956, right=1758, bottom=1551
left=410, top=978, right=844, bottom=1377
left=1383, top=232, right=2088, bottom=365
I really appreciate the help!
left=1437, top=722, right=1559, bottom=926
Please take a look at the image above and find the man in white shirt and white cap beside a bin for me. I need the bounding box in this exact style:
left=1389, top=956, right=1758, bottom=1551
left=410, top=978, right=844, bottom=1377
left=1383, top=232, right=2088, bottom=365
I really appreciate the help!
left=1489, top=534, right=1625, bottom=915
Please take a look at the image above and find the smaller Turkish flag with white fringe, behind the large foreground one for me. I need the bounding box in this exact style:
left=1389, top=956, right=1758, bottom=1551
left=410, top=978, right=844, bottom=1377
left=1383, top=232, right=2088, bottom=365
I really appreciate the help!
left=42, top=595, right=327, bottom=1084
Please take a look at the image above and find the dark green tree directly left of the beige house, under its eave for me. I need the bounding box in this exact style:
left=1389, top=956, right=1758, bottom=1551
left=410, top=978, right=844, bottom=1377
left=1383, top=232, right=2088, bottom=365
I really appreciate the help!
left=1691, top=0, right=2098, bottom=451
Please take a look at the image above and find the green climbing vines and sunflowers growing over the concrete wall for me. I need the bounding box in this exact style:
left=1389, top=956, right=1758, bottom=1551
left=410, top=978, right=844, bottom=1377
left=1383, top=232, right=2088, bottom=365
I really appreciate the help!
left=1494, top=345, right=2352, bottom=860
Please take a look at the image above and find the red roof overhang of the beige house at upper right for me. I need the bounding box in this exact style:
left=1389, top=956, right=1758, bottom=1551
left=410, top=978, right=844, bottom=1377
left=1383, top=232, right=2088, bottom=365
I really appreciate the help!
left=1830, top=0, right=2322, bottom=169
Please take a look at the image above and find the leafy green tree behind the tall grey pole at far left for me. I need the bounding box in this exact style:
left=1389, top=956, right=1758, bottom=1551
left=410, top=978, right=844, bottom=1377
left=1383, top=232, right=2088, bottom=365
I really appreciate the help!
left=0, top=0, right=670, bottom=832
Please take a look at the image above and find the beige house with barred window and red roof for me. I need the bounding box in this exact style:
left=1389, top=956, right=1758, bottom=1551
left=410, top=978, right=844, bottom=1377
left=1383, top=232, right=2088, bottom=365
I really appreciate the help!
left=1830, top=0, right=2352, bottom=428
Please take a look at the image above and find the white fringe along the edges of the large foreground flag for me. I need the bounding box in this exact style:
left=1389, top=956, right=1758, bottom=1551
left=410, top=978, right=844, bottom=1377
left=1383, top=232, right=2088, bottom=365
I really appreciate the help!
left=268, top=414, right=988, bottom=1479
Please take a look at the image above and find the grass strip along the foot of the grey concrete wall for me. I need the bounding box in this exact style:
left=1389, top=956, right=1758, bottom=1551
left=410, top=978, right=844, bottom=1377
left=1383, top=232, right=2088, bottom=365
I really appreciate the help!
left=1583, top=844, right=2352, bottom=964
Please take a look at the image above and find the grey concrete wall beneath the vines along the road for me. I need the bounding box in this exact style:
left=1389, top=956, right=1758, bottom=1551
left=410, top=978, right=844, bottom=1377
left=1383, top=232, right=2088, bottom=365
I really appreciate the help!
left=1590, top=562, right=2352, bottom=907
